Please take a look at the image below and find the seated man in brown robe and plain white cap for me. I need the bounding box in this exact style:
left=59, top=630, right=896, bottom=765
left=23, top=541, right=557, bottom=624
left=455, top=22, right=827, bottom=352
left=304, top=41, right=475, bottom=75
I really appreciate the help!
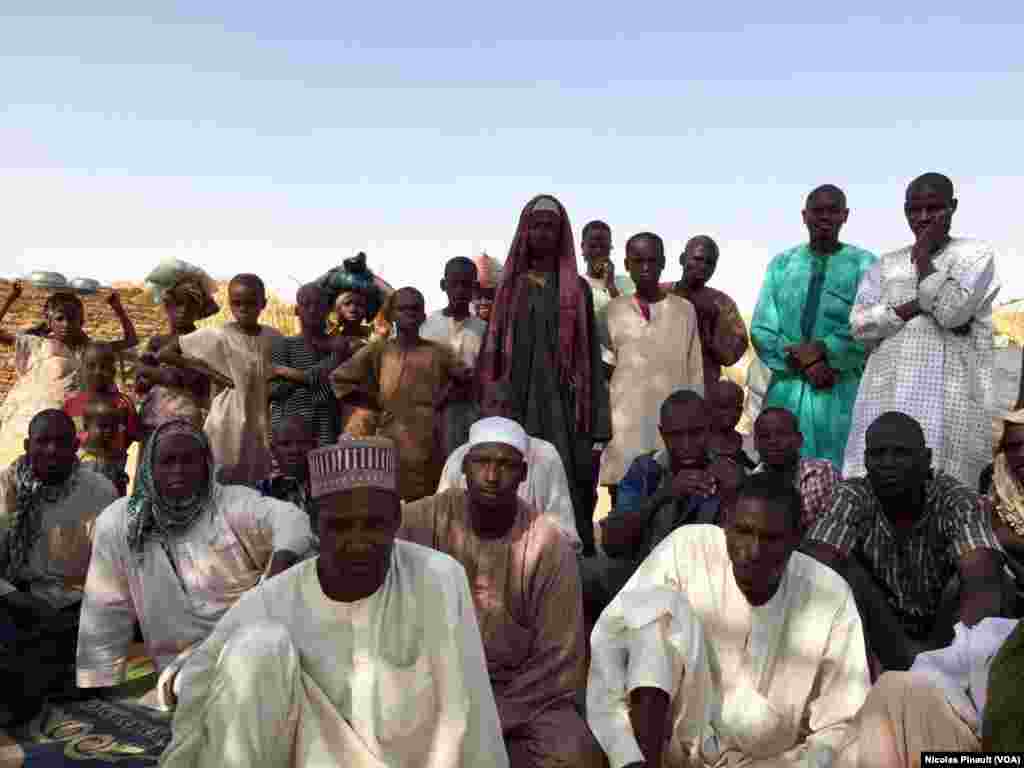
left=398, top=417, right=604, bottom=768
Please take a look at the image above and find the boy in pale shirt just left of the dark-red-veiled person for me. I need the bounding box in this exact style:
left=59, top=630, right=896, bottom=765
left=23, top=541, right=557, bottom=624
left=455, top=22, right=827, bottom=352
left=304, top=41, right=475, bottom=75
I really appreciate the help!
left=420, top=256, right=487, bottom=457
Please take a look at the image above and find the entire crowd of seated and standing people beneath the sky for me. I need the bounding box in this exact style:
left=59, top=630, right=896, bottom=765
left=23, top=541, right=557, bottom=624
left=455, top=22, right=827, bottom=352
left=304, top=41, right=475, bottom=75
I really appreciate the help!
left=0, top=173, right=1024, bottom=768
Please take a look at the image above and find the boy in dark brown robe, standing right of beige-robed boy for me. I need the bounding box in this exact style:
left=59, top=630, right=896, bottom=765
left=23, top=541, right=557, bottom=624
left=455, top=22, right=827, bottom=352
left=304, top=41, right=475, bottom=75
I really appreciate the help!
left=672, top=234, right=750, bottom=386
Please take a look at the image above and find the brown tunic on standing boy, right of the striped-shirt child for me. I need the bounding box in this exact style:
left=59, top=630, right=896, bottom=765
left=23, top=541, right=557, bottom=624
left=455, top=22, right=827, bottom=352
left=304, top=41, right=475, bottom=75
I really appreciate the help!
left=331, top=341, right=458, bottom=501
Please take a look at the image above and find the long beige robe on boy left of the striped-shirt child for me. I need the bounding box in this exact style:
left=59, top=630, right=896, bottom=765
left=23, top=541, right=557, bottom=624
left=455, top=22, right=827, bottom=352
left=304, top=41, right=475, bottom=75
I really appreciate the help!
left=178, top=324, right=281, bottom=484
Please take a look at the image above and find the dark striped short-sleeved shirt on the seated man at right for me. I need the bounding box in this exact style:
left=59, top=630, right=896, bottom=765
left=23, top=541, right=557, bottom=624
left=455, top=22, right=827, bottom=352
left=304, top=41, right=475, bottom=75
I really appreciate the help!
left=806, top=471, right=1001, bottom=639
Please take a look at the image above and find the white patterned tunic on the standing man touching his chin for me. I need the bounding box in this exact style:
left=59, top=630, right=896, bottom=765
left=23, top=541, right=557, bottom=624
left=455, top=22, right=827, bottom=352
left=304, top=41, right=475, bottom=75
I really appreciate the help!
left=843, top=238, right=999, bottom=487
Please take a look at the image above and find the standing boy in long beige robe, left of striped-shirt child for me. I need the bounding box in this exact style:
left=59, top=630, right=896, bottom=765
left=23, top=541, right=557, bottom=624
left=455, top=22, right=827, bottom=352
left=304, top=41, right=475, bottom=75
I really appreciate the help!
left=157, top=273, right=281, bottom=485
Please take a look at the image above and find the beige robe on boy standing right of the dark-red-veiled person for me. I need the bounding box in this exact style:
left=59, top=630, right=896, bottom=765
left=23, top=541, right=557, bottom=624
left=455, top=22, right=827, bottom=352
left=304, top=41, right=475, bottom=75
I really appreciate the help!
left=600, top=294, right=705, bottom=485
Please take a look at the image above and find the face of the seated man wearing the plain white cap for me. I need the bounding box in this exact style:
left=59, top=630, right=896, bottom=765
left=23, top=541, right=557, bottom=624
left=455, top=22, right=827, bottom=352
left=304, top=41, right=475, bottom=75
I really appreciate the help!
left=462, top=442, right=526, bottom=536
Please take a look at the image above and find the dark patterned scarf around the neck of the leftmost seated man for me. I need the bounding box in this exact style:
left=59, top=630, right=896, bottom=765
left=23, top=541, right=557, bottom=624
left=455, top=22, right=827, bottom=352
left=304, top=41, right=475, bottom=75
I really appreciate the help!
left=0, top=456, right=80, bottom=583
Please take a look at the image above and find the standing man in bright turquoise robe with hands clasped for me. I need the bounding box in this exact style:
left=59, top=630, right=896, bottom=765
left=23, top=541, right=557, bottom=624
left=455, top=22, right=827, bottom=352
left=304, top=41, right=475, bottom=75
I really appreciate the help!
left=751, top=184, right=877, bottom=466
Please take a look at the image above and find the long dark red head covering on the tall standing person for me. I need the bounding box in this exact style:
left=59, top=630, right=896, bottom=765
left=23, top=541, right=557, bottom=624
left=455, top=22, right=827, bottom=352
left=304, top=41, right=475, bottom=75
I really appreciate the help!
left=476, top=195, right=592, bottom=434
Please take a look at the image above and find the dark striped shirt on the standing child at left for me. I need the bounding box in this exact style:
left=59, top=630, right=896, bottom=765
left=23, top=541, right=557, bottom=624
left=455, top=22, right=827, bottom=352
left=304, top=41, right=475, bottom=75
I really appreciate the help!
left=269, top=336, right=341, bottom=445
